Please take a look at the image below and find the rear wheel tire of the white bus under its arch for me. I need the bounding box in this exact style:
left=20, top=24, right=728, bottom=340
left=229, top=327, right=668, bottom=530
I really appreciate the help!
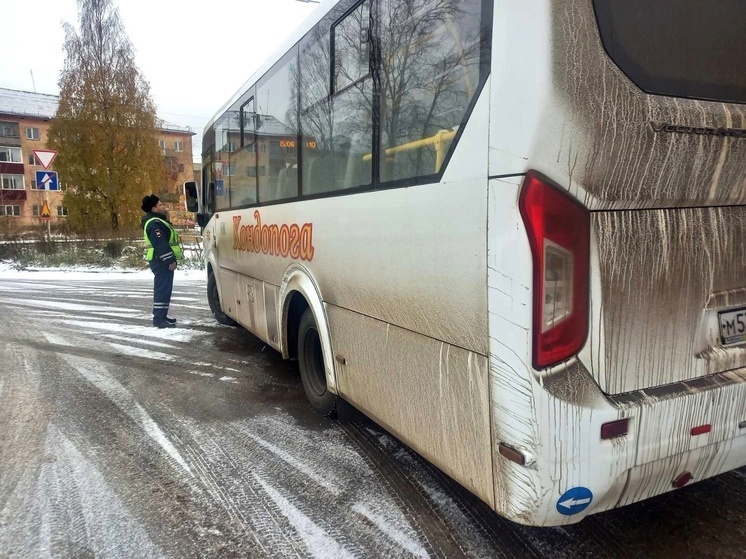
left=298, top=309, right=337, bottom=417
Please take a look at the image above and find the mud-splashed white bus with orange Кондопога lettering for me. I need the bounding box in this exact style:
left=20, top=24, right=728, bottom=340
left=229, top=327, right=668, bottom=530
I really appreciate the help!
left=186, top=0, right=746, bottom=525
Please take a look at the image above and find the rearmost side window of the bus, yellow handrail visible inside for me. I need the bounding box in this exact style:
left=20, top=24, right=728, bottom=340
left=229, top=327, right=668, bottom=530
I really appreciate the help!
left=380, top=0, right=481, bottom=182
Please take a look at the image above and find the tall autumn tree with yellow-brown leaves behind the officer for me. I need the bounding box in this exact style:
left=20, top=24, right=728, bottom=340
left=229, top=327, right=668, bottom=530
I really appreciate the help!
left=49, top=0, right=164, bottom=234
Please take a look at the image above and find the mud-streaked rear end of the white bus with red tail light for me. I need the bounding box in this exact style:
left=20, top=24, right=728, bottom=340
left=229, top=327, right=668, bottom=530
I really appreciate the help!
left=488, top=0, right=746, bottom=525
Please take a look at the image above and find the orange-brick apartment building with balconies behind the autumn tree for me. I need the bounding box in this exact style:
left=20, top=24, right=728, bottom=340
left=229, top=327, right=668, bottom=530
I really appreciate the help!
left=0, top=88, right=194, bottom=231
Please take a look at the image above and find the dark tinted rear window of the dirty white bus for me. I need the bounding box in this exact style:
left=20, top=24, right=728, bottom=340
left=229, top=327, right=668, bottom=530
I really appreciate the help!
left=593, top=0, right=746, bottom=103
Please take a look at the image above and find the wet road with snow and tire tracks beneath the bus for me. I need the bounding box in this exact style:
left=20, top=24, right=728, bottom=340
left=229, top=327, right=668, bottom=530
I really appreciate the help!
left=0, top=271, right=746, bottom=559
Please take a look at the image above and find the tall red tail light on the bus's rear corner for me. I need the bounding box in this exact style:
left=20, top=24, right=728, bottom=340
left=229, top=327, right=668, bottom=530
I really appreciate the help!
left=519, top=171, right=590, bottom=369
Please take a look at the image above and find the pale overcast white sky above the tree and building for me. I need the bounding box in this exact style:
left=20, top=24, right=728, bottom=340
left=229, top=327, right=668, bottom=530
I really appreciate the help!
left=0, top=0, right=317, bottom=160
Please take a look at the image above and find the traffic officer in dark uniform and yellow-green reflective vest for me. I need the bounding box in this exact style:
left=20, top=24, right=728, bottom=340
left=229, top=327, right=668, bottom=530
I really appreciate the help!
left=142, top=194, right=183, bottom=328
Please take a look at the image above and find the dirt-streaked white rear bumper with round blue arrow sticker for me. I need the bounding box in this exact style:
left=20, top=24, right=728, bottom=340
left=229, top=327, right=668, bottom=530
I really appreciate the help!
left=495, top=362, right=746, bottom=526
